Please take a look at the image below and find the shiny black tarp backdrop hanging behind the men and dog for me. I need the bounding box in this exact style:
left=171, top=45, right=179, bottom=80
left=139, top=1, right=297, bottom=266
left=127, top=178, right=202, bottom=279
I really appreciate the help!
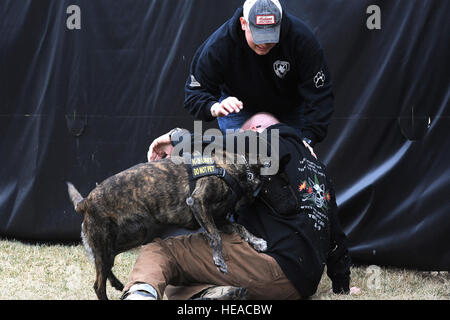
left=0, top=0, right=450, bottom=270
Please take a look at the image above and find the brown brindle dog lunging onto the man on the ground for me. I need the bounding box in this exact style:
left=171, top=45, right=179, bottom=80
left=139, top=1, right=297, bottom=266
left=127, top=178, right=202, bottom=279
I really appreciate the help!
left=67, top=151, right=297, bottom=300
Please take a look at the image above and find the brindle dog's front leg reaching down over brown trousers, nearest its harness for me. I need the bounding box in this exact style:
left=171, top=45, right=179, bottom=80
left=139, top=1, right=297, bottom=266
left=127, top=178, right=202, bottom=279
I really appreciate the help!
left=190, top=199, right=228, bottom=273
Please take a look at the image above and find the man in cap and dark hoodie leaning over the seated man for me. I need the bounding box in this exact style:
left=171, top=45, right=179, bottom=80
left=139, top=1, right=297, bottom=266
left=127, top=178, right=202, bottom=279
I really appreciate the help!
left=184, top=0, right=334, bottom=152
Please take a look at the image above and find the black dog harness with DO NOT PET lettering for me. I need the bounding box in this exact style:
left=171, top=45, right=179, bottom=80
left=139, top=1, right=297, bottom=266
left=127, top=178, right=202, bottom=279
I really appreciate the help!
left=186, top=156, right=243, bottom=207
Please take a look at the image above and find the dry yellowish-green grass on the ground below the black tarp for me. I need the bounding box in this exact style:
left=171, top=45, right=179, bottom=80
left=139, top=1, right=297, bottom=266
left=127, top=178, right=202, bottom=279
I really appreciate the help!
left=0, top=240, right=450, bottom=300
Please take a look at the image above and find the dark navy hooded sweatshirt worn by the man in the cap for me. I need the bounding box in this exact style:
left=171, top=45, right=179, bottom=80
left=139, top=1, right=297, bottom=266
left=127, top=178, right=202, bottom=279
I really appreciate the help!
left=184, top=8, right=334, bottom=145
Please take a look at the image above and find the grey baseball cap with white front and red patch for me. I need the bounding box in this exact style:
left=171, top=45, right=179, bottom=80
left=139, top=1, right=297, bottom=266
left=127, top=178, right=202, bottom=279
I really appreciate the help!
left=244, top=0, right=283, bottom=44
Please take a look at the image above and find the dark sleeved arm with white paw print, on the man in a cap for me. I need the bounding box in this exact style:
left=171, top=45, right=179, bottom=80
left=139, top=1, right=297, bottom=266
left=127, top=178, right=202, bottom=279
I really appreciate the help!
left=298, top=48, right=334, bottom=147
